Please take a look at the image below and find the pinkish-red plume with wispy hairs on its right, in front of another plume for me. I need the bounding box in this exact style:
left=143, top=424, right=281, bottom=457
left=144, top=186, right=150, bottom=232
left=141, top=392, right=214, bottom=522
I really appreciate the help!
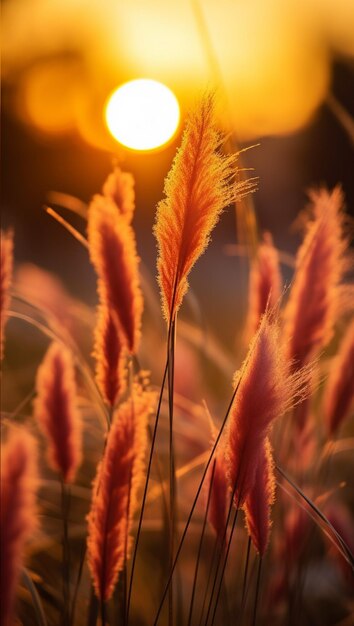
left=226, top=313, right=308, bottom=506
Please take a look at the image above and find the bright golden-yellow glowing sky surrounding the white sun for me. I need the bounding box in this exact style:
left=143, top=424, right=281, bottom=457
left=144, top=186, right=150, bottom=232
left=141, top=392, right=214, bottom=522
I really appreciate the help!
left=2, top=0, right=354, bottom=146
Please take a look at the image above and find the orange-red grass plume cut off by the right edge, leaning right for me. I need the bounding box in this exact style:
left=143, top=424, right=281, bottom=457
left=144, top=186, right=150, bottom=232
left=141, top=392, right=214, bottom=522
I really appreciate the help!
left=323, top=322, right=354, bottom=436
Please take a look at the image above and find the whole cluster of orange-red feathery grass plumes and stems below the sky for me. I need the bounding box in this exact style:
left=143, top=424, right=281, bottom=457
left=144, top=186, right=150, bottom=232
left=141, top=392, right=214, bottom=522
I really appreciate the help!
left=1, top=96, right=354, bottom=626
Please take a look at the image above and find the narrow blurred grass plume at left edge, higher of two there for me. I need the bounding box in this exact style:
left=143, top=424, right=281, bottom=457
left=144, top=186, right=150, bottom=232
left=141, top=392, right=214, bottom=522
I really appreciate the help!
left=0, top=231, right=13, bottom=361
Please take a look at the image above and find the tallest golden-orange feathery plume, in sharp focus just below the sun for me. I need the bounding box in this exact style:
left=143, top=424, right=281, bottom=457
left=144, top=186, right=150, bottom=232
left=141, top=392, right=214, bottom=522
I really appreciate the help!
left=154, top=95, right=252, bottom=321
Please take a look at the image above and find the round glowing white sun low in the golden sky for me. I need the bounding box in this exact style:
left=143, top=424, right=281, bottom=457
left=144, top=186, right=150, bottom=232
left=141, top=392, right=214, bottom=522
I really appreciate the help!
left=105, top=78, right=180, bottom=151
